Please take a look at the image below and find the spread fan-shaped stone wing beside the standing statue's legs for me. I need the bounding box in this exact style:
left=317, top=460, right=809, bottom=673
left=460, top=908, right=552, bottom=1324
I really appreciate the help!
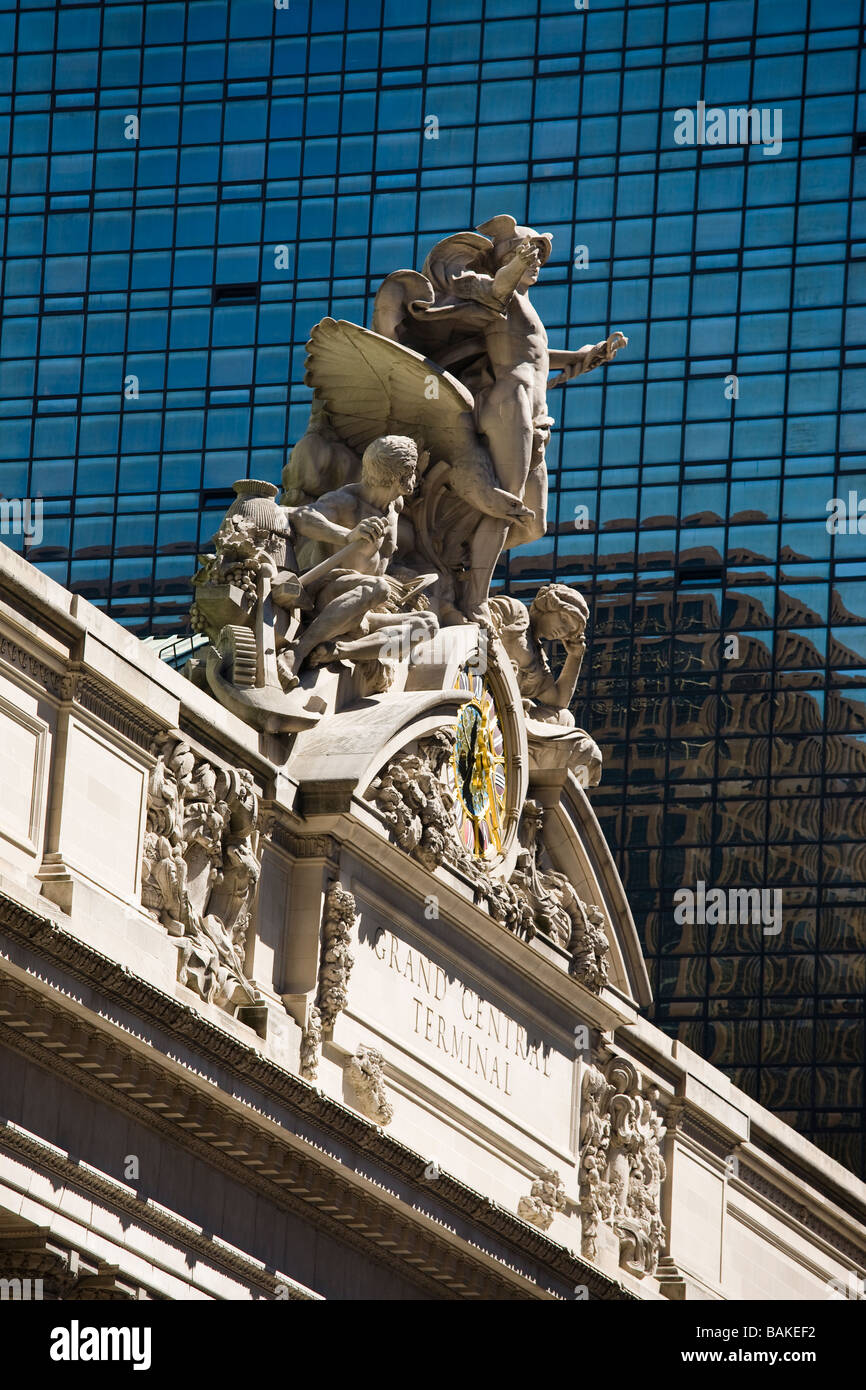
left=304, top=318, right=475, bottom=463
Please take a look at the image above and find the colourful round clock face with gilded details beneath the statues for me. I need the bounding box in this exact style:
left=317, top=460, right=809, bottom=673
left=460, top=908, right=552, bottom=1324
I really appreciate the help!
left=445, top=670, right=507, bottom=859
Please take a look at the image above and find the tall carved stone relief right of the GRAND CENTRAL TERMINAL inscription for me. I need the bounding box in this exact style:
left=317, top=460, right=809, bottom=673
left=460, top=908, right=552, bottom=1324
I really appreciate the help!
left=580, top=1058, right=667, bottom=1279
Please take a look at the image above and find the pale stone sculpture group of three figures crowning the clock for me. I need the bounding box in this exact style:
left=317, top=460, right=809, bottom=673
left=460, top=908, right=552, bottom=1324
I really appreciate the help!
left=189, top=215, right=626, bottom=733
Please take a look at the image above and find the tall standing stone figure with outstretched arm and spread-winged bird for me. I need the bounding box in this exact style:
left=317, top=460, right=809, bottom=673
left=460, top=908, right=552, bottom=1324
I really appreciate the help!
left=304, top=214, right=627, bottom=621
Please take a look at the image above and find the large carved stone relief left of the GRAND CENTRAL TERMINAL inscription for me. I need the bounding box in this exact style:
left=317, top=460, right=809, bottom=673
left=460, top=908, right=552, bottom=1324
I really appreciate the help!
left=142, top=730, right=261, bottom=1009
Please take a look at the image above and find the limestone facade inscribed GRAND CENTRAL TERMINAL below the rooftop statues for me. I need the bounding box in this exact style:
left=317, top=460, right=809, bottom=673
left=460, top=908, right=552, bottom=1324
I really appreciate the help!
left=0, top=548, right=866, bottom=1301
